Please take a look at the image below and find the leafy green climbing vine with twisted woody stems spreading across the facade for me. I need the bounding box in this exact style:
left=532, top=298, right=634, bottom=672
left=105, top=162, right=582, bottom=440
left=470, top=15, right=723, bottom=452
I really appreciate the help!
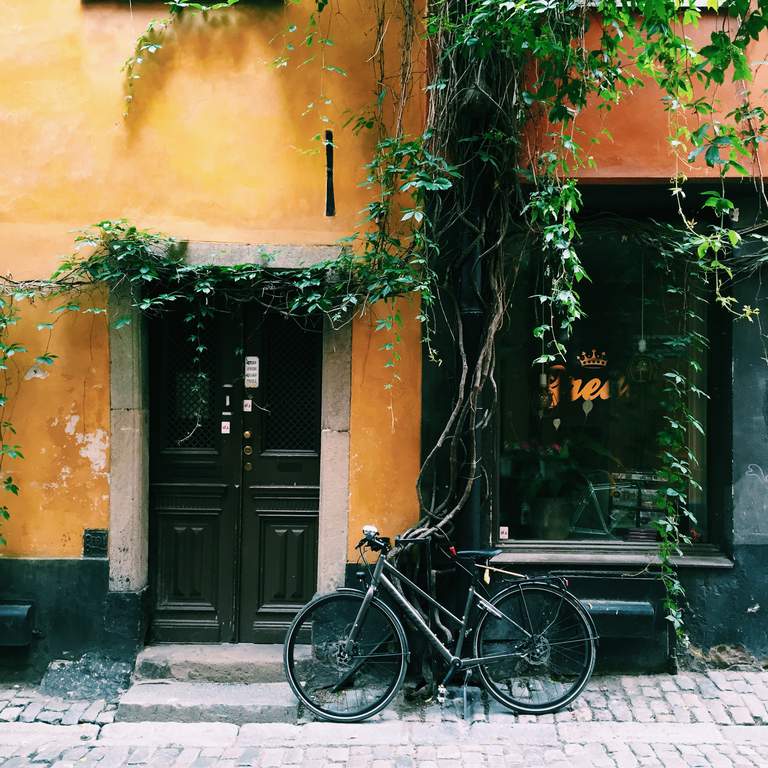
left=0, top=0, right=768, bottom=652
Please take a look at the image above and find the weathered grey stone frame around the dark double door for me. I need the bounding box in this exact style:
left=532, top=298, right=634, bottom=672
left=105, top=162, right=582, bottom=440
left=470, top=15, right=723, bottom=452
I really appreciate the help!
left=109, top=242, right=352, bottom=608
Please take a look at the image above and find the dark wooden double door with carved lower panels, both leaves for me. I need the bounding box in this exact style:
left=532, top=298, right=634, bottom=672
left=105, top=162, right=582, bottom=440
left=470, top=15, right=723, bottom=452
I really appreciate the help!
left=150, top=305, right=322, bottom=643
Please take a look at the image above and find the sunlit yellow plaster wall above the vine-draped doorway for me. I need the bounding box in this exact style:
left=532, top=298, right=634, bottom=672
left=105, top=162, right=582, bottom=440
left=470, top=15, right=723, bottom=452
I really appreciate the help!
left=0, top=0, right=418, bottom=276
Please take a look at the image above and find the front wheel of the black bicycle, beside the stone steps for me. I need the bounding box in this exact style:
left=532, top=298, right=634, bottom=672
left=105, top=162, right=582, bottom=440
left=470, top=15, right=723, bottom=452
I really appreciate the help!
left=283, top=592, right=408, bottom=723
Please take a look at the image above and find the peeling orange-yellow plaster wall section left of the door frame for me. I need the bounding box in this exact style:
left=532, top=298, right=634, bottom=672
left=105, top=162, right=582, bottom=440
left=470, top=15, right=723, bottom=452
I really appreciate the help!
left=2, top=294, right=109, bottom=557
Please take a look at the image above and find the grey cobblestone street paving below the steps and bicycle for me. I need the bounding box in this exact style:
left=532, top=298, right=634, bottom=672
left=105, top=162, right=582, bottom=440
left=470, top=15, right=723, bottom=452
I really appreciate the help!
left=0, top=671, right=768, bottom=768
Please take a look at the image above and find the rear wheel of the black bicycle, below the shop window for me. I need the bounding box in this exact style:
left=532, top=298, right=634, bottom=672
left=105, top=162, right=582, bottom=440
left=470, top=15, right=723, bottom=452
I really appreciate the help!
left=475, top=584, right=597, bottom=715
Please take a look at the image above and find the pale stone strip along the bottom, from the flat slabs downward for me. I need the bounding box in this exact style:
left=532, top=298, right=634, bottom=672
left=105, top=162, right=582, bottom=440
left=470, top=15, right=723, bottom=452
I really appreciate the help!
left=0, top=721, right=768, bottom=768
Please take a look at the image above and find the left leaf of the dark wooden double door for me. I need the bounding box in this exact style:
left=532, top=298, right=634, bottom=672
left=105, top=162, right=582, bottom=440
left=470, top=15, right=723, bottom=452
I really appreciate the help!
left=150, top=312, right=240, bottom=642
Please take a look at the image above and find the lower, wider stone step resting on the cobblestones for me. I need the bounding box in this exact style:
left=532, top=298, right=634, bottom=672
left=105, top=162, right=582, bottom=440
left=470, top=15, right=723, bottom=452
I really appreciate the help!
left=115, top=680, right=298, bottom=725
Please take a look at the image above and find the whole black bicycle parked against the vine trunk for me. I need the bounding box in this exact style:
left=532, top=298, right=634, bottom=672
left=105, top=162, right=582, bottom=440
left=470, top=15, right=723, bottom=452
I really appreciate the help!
left=283, top=526, right=598, bottom=723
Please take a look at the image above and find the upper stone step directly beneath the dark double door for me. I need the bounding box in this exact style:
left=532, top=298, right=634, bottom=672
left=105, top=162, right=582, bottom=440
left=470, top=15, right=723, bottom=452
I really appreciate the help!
left=134, top=643, right=308, bottom=683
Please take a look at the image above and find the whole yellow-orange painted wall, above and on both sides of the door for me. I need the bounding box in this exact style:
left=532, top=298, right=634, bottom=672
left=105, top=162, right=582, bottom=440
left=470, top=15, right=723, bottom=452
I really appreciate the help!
left=0, top=0, right=422, bottom=556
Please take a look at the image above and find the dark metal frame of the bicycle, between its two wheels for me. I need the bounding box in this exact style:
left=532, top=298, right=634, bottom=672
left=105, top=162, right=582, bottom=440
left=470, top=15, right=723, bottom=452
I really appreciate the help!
left=347, top=553, right=532, bottom=685
